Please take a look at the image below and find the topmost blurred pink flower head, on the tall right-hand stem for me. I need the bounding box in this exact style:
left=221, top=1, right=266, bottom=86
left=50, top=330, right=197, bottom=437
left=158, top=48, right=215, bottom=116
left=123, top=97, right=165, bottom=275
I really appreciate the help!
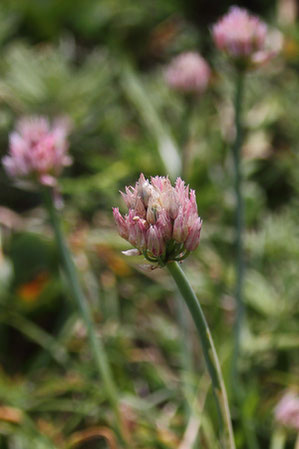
left=212, top=6, right=273, bottom=67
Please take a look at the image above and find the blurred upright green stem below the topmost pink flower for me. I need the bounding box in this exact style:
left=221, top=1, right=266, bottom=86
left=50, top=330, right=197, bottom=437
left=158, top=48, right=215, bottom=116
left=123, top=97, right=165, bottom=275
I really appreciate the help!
left=232, top=70, right=245, bottom=386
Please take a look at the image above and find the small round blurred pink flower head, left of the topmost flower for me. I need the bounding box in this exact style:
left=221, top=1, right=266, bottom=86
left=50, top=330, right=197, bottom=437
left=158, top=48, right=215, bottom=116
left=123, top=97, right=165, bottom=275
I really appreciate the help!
left=165, top=52, right=211, bottom=93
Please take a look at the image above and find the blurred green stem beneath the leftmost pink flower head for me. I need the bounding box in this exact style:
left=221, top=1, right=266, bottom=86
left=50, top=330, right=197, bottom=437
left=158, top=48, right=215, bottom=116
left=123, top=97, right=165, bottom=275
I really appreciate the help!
left=43, top=189, right=127, bottom=447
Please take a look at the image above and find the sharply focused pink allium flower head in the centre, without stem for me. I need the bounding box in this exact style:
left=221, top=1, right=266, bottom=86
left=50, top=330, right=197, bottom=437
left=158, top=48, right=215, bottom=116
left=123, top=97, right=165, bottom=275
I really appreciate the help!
left=113, top=174, right=202, bottom=266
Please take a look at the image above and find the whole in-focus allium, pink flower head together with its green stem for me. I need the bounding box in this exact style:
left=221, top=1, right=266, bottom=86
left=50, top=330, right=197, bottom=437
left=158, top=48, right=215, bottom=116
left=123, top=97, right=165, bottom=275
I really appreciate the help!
left=113, top=174, right=235, bottom=449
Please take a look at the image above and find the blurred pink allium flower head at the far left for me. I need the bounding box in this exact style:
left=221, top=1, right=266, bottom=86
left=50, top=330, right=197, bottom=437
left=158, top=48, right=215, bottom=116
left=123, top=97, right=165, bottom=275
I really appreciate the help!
left=2, top=117, right=72, bottom=186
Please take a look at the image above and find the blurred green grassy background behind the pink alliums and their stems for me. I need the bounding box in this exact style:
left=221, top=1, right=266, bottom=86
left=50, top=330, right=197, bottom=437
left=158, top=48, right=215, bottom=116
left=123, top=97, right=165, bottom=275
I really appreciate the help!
left=0, top=0, right=299, bottom=449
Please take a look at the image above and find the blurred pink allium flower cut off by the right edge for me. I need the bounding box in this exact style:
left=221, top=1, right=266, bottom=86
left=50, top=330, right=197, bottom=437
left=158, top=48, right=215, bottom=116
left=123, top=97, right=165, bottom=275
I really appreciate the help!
left=275, top=392, right=299, bottom=431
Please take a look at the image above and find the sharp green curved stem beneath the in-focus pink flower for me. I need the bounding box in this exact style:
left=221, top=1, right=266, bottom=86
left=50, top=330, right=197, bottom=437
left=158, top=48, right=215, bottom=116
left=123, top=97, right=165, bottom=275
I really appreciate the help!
left=166, top=262, right=235, bottom=449
